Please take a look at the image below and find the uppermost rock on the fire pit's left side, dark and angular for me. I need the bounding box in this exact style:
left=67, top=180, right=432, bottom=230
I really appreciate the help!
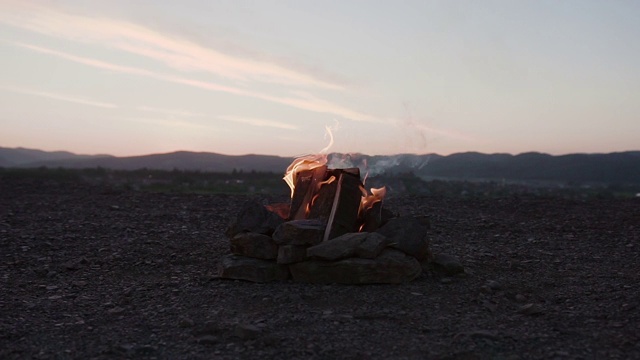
left=225, top=200, right=284, bottom=239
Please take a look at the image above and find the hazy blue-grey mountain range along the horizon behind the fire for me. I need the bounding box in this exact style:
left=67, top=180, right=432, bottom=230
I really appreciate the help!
left=0, top=147, right=640, bottom=184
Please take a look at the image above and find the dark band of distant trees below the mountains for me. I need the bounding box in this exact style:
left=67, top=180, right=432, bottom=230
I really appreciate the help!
left=0, top=167, right=640, bottom=198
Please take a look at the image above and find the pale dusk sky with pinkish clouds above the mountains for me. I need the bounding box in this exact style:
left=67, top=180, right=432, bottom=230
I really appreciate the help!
left=0, top=0, right=640, bottom=156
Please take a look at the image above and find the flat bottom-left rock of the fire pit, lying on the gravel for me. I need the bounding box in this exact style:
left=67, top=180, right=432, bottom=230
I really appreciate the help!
left=218, top=255, right=289, bottom=283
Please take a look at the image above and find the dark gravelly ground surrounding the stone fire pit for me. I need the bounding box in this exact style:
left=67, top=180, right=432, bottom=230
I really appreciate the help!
left=0, top=179, right=640, bottom=359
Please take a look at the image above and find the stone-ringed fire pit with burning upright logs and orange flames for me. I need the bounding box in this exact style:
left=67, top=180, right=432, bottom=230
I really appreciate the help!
left=219, top=155, right=430, bottom=284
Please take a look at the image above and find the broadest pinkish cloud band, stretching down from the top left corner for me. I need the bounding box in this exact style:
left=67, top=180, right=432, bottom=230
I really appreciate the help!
left=0, top=0, right=345, bottom=90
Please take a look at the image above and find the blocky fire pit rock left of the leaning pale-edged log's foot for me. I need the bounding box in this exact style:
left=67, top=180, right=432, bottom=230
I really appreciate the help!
left=273, top=219, right=325, bottom=245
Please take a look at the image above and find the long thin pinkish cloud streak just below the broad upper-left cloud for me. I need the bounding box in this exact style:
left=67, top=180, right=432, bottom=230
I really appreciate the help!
left=5, top=41, right=386, bottom=123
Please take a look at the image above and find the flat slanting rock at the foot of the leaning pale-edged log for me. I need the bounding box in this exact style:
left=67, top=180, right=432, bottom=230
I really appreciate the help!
left=307, top=232, right=389, bottom=261
